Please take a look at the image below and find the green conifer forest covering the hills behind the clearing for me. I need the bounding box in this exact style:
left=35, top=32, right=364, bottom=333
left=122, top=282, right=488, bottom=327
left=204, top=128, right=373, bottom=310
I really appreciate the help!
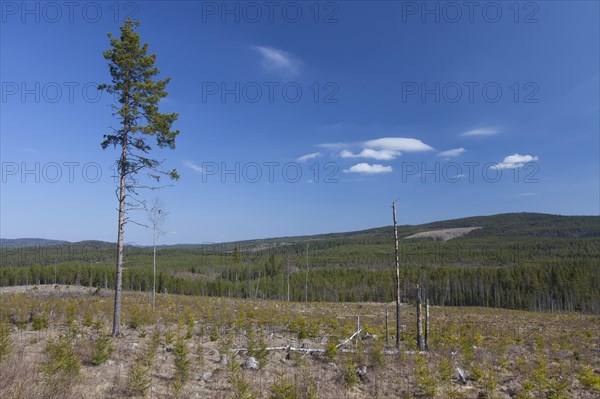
left=0, top=213, right=600, bottom=313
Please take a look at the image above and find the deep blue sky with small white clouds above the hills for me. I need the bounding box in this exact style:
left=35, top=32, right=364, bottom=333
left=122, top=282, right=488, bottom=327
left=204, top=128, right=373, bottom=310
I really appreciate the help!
left=0, top=1, right=600, bottom=244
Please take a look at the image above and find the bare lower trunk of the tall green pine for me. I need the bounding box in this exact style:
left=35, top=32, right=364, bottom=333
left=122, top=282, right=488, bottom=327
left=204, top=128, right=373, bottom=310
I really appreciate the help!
left=112, top=134, right=127, bottom=337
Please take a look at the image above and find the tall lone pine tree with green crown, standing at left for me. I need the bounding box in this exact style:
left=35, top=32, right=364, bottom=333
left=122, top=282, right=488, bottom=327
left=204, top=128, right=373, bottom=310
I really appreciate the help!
left=98, top=19, right=179, bottom=336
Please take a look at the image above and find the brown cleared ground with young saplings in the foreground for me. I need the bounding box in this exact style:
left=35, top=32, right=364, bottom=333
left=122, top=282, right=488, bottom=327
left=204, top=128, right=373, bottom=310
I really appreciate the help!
left=0, top=286, right=600, bottom=399
